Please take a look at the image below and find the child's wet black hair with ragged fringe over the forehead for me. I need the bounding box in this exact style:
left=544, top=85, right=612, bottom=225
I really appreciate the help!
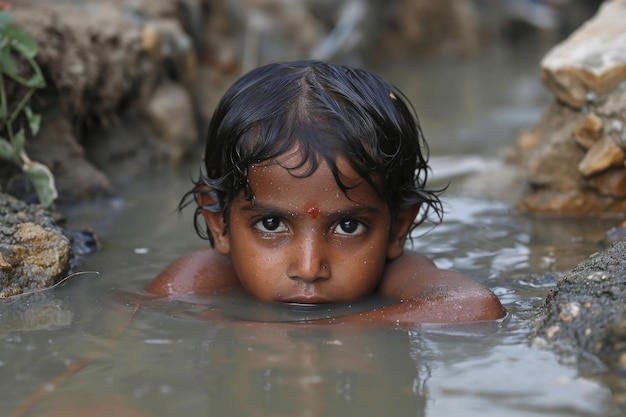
left=180, top=61, right=443, bottom=244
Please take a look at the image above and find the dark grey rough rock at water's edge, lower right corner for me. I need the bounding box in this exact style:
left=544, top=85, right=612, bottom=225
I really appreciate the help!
left=531, top=237, right=626, bottom=375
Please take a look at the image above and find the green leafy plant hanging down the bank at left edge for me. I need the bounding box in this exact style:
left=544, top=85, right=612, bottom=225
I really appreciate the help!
left=0, top=11, right=58, bottom=207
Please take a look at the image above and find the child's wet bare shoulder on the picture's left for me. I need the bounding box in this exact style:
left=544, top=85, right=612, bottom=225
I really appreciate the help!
left=145, top=249, right=237, bottom=296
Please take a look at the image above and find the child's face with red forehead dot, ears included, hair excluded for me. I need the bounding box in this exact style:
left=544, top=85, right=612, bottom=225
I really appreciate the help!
left=205, top=151, right=413, bottom=303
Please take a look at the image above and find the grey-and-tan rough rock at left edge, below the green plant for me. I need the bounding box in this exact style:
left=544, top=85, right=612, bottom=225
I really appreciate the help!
left=0, top=194, right=72, bottom=298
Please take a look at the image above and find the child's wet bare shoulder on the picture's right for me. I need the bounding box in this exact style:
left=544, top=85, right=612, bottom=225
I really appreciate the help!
left=380, top=251, right=506, bottom=322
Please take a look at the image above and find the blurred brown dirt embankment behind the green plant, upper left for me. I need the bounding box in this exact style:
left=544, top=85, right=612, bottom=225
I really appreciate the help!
left=0, top=1, right=233, bottom=202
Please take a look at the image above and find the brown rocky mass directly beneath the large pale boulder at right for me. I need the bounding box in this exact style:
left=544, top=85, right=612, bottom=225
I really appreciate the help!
left=512, top=91, right=626, bottom=211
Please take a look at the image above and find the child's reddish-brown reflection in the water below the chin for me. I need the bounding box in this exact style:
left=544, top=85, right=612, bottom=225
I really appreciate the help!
left=197, top=322, right=428, bottom=416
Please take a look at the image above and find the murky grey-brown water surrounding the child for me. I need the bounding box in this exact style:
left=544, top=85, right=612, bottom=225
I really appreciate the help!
left=0, top=47, right=623, bottom=417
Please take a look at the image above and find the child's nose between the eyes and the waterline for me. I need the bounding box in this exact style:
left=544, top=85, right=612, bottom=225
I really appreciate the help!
left=287, top=235, right=330, bottom=282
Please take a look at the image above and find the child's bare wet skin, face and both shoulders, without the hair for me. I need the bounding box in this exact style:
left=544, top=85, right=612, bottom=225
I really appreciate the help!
left=147, top=150, right=505, bottom=325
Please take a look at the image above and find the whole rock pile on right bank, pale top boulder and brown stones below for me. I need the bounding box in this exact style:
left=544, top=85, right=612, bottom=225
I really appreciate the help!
left=513, top=0, right=626, bottom=216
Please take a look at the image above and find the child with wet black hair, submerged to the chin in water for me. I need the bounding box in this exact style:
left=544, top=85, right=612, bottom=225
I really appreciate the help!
left=146, top=61, right=505, bottom=325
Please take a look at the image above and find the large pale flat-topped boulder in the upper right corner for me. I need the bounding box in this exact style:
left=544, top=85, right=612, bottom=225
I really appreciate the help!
left=541, top=0, right=626, bottom=108
